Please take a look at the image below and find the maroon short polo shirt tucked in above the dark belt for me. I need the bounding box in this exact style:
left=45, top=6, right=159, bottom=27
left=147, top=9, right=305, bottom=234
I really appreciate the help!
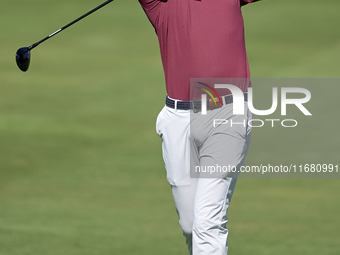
left=139, top=0, right=258, bottom=101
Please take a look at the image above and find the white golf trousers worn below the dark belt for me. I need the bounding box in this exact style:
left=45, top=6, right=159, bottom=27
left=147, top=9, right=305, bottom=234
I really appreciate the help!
left=156, top=102, right=251, bottom=255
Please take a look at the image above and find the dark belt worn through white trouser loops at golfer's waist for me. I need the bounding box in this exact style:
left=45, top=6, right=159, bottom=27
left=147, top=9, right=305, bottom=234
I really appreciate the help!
left=165, top=92, right=248, bottom=112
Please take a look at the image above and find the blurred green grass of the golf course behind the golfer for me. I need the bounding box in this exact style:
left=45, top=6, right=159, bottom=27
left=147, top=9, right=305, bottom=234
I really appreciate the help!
left=0, top=0, right=340, bottom=255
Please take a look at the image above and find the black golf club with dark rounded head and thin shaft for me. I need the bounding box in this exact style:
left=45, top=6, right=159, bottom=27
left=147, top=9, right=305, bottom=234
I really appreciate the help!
left=15, top=0, right=113, bottom=72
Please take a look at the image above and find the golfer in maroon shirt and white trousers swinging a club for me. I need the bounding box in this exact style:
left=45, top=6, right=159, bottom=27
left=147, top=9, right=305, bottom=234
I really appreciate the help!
left=139, top=0, right=257, bottom=255
